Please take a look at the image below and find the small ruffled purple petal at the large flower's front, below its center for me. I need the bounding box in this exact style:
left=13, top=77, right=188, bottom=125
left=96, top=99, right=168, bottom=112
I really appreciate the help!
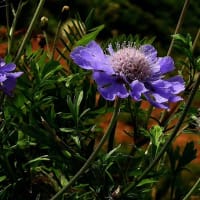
left=130, top=80, right=148, bottom=101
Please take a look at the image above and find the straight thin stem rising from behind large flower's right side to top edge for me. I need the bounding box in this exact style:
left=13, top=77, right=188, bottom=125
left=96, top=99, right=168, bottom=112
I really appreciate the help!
left=167, top=0, right=190, bottom=56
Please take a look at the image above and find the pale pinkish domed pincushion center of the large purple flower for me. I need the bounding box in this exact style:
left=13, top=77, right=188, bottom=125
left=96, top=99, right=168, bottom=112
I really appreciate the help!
left=111, top=47, right=151, bottom=82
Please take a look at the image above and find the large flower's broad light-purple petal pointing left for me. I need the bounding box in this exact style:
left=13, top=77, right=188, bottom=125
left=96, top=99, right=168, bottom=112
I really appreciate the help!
left=70, top=41, right=114, bottom=74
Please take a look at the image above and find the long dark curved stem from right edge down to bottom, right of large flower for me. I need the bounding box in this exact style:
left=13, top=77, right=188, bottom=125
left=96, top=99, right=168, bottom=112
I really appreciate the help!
left=122, top=73, right=200, bottom=194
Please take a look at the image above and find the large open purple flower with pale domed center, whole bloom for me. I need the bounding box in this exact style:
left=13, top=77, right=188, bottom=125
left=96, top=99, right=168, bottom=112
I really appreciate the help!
left=71, top=41, right=185, bottom=109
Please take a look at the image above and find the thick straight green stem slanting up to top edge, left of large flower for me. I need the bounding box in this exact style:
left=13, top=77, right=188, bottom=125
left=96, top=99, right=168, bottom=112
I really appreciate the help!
left=14, top=0, right=45, bottom=63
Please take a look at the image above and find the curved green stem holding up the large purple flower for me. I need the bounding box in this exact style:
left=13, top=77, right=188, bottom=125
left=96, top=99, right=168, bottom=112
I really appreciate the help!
left=50, top=99, right=120, bottom=200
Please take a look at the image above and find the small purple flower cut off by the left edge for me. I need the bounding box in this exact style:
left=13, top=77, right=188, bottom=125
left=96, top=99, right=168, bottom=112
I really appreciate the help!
left=0, top=58, right=23, bottom=96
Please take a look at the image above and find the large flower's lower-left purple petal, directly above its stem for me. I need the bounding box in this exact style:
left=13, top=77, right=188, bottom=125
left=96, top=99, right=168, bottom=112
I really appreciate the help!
left=93, top=72, right=129, bottom=101
